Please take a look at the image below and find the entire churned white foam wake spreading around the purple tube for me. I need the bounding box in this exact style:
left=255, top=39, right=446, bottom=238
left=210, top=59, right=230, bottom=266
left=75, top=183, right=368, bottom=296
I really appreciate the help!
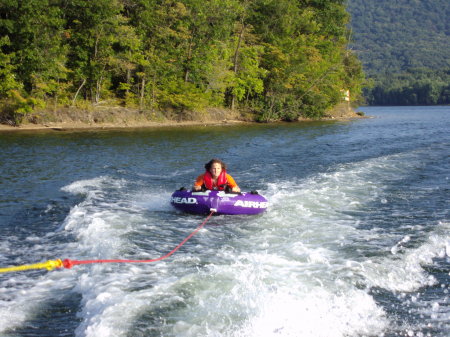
left=0, top=148, right=450, bottom=337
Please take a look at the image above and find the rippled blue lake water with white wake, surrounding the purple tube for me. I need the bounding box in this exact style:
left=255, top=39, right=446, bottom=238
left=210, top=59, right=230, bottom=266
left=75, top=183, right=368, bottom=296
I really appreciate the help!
left=0, top=107, right=450, bottom=337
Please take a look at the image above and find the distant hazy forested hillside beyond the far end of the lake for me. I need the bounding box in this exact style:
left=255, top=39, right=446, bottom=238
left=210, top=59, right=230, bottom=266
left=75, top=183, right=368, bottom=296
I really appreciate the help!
left=348, top=0, right=450, bottom=105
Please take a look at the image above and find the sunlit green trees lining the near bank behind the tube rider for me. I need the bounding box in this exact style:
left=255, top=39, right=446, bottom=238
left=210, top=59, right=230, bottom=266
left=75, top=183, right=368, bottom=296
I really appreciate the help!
left=0, top=0, right=364, bottom=124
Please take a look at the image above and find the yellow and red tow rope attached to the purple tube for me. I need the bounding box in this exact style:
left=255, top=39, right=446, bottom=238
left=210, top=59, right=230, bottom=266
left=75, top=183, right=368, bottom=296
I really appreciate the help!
left=0, top=209, right=215, bottom=273
